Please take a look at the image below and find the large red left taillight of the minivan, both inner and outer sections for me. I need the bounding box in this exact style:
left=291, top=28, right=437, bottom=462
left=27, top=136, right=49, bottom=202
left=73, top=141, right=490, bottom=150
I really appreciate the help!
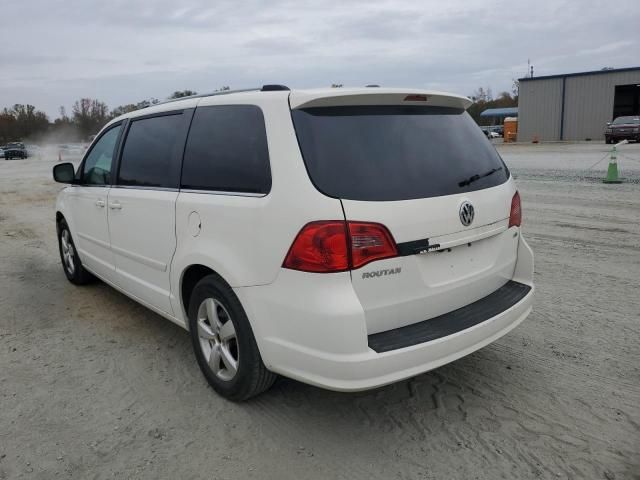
left=282, top=220, right=398, bottom=273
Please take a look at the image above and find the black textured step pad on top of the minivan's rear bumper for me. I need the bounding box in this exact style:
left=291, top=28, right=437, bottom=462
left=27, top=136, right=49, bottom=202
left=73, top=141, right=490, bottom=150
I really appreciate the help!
left=368, top=280, right=531, bottom=353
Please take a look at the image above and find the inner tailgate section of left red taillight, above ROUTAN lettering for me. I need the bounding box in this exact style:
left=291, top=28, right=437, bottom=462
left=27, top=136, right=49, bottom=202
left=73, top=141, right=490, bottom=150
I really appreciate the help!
left=347, top=222, right=398, bottom=268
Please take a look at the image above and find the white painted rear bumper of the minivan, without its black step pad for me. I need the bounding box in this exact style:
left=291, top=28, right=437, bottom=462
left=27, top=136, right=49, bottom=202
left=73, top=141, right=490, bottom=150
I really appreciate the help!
left=236, top=238, right=534, bottom=391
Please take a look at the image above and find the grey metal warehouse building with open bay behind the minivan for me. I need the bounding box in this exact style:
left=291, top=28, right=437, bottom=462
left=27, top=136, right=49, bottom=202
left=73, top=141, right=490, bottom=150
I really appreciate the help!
left=518, top=67, right=640, bottom=142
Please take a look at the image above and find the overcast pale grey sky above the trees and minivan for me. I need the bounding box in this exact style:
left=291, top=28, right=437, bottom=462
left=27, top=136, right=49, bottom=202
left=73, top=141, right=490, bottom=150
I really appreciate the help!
left=0, top=0, right=640, bottom=119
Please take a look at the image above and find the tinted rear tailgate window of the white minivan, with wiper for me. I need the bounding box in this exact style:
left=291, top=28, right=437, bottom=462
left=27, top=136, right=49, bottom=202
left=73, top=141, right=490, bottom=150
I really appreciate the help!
left=292, top=106, right=509, bottom=201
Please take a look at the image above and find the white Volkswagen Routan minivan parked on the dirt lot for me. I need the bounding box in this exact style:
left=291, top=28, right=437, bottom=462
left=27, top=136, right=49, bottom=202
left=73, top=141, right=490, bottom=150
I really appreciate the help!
left=53, top=85, right=534, bottom=400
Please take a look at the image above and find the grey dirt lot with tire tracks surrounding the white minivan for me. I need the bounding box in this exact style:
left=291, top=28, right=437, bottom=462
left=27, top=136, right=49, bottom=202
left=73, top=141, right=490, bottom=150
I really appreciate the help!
left=0, top=144, right=640, bottom=480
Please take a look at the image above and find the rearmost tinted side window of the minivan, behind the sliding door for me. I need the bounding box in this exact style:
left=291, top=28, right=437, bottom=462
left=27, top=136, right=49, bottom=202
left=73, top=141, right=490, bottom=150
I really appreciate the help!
left=181, top=105, right=271, bottom=194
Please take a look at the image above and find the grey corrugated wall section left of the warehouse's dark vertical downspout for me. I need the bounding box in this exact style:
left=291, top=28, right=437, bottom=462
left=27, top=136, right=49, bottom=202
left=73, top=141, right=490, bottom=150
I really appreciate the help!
left=518, top=78, right=562, bottom=142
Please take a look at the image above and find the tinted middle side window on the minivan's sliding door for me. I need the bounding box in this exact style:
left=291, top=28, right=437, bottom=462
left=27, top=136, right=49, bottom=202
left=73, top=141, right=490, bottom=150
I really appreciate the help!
left=118, top=113, right=184, bottom=188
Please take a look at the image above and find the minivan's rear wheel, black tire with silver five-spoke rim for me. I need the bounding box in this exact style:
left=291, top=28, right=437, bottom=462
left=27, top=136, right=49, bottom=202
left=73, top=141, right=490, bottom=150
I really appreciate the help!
left=189, top=275, right=277, bottom=401
